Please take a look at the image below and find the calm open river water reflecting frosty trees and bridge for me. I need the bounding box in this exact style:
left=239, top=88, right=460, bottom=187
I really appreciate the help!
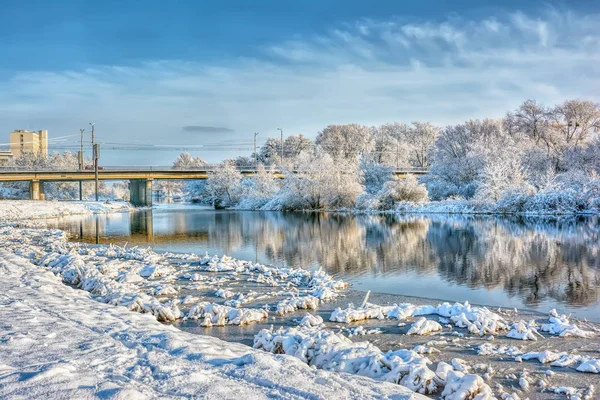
left=47, top=205, right=600, bottom=321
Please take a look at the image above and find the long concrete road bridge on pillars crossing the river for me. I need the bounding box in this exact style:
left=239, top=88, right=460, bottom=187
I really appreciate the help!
left=0, top=164, right=428, bottom=206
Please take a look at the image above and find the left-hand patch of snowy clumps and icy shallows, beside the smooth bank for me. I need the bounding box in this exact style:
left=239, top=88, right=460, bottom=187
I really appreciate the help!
left=0, top=226, right=347, bottom=326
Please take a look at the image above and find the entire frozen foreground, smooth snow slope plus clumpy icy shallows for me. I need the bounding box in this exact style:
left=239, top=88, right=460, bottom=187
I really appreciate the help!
left=0, top=202, right=600, bottom=400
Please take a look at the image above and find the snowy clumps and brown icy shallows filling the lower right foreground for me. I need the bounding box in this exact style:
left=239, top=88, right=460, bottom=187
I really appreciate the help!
left=254, top=303, right=600, bottom=400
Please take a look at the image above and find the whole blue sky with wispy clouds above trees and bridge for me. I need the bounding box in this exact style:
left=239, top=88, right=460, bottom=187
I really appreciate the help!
left=0, top=0, right=600, bottom=165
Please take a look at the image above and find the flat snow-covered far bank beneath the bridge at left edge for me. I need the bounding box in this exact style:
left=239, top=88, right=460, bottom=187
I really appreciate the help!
left=0, top=200, right=133, bottom=221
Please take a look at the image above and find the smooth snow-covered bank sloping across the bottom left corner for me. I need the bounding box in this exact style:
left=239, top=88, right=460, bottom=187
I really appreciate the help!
left=0, top=250, right=422, bottom=399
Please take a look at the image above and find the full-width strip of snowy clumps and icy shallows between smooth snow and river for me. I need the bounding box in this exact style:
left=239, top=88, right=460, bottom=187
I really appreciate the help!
left=2, top=217, right=600, bottom=399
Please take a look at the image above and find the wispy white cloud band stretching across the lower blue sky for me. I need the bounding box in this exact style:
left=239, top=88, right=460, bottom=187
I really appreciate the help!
left=0, top=10, right=600, bottom=159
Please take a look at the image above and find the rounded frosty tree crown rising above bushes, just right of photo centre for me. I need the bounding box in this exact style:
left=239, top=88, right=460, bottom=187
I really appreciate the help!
left=315, top=124, right=375, bottom=162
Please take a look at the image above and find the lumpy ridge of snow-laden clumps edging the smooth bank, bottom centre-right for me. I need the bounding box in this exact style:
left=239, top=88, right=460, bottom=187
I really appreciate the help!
left=254, top=321, right=493, bottom=400
